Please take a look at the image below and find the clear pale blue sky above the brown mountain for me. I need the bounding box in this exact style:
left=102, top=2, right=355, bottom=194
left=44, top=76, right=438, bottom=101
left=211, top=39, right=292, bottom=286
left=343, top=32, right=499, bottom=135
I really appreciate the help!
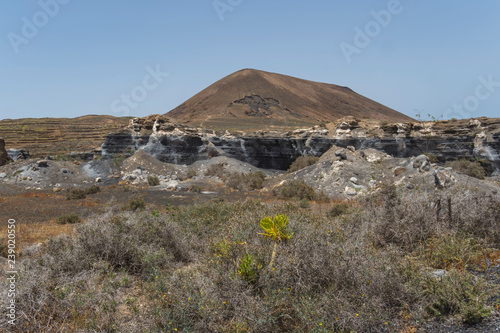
left=0, top=0, right=500, bottom=119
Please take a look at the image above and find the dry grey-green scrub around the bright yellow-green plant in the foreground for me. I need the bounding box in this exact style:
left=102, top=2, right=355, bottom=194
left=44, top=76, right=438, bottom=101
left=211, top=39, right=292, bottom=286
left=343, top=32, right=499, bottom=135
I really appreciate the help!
left=1, top=186, right=500, bottom=332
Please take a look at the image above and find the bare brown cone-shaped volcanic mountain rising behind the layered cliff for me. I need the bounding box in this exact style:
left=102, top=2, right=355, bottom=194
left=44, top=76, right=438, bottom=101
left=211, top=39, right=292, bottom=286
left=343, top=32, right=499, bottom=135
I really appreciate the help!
left=167, top=69, right=413, bottom=129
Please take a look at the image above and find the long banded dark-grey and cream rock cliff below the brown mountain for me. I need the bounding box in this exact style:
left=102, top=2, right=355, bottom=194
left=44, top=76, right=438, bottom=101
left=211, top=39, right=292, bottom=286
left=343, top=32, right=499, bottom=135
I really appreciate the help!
left=102, top=116, right=500, bottom=174
